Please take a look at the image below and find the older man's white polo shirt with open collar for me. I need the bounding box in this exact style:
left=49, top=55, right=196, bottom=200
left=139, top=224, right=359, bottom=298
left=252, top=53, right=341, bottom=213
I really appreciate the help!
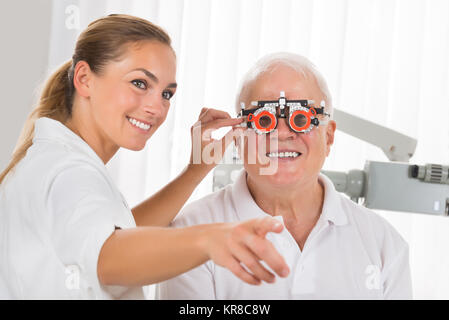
left=156, top=170, right=412, bottom=299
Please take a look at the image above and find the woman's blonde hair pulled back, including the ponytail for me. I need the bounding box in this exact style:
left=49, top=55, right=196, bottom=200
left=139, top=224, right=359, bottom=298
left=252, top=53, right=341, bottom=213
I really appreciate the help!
left=0, top=14, right=171, bottom=184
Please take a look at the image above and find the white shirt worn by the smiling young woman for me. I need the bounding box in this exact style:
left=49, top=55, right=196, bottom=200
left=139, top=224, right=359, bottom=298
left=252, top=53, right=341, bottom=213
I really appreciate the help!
left=0, top=118, right=144, bottom=299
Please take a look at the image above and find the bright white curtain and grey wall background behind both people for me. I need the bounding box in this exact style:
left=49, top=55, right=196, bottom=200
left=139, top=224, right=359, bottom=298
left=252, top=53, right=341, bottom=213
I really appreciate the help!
left=0, top=0, right=449, bottom=299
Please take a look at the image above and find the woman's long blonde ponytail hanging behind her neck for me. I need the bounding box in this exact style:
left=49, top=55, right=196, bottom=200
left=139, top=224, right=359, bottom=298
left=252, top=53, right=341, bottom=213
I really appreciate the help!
left=0, top=60, right=74, bottom=184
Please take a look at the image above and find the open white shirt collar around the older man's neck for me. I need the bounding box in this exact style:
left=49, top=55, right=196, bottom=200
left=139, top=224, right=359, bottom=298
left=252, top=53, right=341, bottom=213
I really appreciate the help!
left=232, top=169, right=348, bottom=226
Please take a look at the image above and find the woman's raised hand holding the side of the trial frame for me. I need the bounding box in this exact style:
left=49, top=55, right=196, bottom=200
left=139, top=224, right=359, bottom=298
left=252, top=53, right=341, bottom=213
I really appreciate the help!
left=189, top=108, right=243, bottom=176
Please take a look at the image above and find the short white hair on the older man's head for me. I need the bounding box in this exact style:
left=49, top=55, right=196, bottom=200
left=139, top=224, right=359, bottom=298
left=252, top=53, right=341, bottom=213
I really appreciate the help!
left=235, top=52, right=333, bottom=119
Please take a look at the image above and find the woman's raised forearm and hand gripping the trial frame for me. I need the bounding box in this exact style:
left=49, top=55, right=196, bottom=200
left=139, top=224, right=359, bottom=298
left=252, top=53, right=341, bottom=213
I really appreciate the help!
left=132, top=108, right=242, bottom=227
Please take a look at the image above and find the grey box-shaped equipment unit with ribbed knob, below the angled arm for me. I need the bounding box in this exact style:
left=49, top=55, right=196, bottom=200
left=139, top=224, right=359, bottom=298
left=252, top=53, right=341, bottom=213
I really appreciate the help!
left=322, top=161, right=449, bottom=216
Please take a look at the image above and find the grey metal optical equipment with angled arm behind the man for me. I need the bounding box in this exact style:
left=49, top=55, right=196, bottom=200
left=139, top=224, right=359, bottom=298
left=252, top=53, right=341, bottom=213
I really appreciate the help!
left=213, top=109, right=449, bottom=216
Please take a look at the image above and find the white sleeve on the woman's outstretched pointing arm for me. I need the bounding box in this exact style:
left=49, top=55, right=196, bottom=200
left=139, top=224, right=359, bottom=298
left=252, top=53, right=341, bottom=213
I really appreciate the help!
left=46, top=164, right=137, bottom=299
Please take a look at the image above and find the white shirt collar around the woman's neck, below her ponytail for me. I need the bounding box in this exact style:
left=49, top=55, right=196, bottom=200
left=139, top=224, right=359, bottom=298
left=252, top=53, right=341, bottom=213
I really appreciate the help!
left=33, top=117, right=104, bottom=166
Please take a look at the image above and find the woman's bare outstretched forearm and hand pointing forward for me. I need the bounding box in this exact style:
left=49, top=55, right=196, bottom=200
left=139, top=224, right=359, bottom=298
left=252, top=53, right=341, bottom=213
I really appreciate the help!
left=97, top=217, right=289, bottom=286
